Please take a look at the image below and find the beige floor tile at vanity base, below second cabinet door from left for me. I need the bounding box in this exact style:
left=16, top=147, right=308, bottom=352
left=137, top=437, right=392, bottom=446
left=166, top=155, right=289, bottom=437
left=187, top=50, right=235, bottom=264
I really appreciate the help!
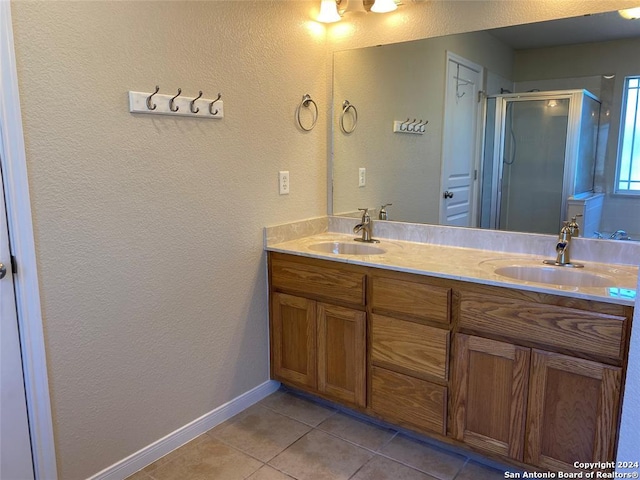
left=318, top=413, right=396, bottom=451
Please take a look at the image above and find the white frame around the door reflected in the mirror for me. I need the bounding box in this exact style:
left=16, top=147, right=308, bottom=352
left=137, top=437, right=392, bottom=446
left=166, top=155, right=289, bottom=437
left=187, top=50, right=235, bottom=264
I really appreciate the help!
left=438, top=50, right=486, bottom=228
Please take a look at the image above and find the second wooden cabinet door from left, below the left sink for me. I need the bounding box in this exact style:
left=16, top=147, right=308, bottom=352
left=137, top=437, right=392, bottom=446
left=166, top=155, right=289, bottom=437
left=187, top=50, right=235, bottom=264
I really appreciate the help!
left=317, top=303, right=366, bottom=407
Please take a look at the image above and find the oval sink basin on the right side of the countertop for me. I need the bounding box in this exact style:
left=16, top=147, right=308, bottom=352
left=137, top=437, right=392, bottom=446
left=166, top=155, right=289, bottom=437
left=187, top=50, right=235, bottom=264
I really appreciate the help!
left=494, top=265, right=616, bottom=287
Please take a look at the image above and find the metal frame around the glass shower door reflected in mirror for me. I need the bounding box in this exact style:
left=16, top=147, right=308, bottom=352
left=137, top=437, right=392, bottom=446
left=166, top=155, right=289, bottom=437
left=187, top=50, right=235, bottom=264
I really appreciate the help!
left=485, top=90, right=600, bottom=230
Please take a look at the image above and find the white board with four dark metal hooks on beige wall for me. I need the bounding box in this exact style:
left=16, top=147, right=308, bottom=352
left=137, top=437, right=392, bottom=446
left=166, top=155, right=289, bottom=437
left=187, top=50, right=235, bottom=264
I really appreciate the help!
left=129, top=85, right=224, bottom=118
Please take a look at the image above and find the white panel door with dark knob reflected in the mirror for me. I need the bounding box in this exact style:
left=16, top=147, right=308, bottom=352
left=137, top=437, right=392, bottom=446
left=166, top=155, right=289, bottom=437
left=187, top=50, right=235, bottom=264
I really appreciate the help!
left=440, top=52, right=483, bottom=227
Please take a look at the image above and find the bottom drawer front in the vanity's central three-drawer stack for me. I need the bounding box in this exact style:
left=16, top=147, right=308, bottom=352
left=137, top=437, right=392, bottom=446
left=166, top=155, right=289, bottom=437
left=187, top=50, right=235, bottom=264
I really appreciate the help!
left=371, top=367, right=447, bottom=435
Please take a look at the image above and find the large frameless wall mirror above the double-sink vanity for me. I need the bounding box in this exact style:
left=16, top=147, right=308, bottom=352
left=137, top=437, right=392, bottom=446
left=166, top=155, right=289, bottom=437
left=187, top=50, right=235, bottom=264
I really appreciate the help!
left=330, top=12, right=640, bottom=240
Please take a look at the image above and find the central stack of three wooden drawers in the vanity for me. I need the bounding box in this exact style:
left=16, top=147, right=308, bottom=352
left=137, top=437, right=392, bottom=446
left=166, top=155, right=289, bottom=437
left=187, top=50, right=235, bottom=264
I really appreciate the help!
left=370, top=274, right=451, bottom=436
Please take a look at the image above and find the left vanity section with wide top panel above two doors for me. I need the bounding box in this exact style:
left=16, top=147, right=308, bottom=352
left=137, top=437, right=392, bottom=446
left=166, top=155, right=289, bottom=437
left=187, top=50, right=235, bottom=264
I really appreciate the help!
left=270, top=255, right=367, bottom=407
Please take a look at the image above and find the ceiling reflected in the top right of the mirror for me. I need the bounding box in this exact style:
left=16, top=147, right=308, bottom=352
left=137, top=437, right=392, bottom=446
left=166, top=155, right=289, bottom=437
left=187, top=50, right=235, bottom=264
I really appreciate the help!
left=488, top=12, right=640, bottom=50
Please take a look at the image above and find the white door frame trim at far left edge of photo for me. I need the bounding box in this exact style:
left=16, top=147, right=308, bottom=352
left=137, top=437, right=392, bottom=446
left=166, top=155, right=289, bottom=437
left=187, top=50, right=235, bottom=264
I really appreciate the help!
left=0, top=0, right=58, bottom=480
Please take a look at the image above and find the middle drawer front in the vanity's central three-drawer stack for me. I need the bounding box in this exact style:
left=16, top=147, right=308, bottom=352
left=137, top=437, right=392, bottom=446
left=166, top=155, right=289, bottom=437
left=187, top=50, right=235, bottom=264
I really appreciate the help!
left=371, top=315, right=449, bottom=380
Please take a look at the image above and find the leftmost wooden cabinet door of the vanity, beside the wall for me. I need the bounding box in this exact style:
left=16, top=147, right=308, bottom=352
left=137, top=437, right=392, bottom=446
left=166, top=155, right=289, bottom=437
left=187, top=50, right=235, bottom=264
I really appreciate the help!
left=271, top=293, right=316, bottom=389
